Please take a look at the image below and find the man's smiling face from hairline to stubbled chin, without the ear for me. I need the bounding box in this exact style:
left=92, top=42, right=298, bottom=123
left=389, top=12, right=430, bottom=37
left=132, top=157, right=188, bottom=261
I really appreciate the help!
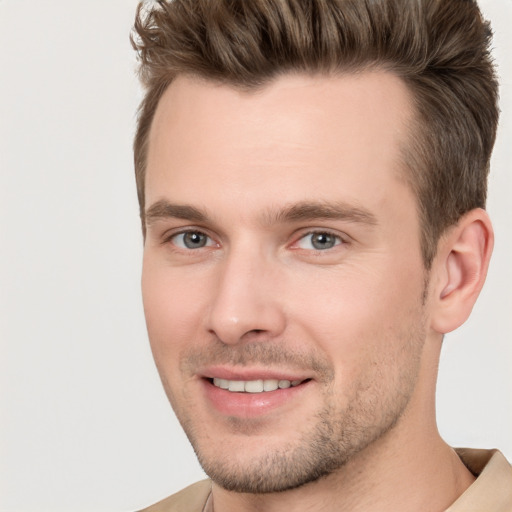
left=142, top=72, right=428, bottom=492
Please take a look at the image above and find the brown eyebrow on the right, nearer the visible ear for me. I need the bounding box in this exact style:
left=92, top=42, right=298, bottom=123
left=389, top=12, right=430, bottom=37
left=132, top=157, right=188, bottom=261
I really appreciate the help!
left=264, top=201, right=378, bottom=226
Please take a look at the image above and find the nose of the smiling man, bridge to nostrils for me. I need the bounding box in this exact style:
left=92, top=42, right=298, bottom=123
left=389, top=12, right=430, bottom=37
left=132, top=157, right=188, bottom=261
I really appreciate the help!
left=207, top=247, right=286, bottom=345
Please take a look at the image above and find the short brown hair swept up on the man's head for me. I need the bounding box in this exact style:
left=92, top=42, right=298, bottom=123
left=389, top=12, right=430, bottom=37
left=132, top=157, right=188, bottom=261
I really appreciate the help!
left=132, top=0, right=498, bottom=269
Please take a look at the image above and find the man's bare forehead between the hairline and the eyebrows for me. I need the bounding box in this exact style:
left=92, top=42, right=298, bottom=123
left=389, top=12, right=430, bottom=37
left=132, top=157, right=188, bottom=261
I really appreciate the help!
left=146, top=71, right=411, bottom=222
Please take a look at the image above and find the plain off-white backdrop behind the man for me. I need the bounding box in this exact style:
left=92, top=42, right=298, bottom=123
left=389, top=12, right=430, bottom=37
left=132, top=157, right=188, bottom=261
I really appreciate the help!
left=0, top=0, right=512, bottom=512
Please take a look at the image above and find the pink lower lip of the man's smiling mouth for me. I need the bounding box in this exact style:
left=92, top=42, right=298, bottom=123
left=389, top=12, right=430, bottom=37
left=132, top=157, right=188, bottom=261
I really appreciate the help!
left=202, top=379, right=311, bottom=418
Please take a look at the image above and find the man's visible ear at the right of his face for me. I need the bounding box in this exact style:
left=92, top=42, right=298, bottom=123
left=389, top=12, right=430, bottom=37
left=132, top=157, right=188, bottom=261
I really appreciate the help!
left=431, top=208, right=494, bottom=334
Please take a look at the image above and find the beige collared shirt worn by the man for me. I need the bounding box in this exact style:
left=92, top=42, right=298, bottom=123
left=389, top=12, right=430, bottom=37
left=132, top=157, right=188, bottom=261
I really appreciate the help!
left=140, top=448, right=512, bottom=512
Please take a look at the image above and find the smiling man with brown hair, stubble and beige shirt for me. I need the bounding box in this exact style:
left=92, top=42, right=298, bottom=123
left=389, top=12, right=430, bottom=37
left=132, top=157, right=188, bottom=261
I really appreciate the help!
left=134, top=0, right=512, bottom=512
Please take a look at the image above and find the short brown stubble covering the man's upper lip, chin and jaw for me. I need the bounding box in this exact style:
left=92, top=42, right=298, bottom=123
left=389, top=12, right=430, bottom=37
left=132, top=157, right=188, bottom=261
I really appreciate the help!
left=157, top=318, right=425, bottom=494
